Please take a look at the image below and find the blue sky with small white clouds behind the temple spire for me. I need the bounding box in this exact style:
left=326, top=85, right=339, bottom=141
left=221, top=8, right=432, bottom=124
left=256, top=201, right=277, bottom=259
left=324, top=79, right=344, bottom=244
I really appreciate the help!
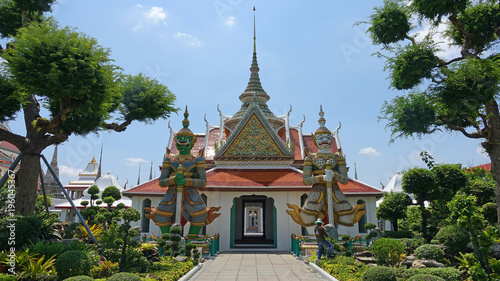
left=4, top=0, right=489, bottom=188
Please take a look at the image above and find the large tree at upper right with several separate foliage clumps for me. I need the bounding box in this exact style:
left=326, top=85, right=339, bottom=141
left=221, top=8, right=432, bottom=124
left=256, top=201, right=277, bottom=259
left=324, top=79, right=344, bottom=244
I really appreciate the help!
left=368, top=0, right=500, bottom=231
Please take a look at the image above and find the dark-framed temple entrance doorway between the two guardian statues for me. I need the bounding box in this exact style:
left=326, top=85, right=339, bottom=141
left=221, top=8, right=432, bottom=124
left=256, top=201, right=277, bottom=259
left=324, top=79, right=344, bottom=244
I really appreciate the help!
left=231, top=195, right=276, bottom=248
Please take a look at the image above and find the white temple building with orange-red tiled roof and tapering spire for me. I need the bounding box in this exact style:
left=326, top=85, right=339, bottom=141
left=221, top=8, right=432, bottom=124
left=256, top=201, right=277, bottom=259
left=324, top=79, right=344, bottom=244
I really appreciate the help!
left=122, top=23, right=382, bottom=251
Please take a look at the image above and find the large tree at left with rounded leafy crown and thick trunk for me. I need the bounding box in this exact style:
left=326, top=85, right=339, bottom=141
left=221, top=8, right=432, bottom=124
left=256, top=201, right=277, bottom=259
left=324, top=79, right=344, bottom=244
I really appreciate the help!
left=0, top=0, right=177, bottom=214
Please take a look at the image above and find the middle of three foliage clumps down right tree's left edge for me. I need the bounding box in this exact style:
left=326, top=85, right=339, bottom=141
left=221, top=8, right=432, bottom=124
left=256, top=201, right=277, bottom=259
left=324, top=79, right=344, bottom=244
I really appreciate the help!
left=387, top=43, right=437, bottom=90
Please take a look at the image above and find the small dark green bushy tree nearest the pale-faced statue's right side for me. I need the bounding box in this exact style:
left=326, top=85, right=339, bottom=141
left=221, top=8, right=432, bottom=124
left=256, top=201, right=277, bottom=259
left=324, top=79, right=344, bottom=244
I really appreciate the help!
left=375, top=192, right=412, bottom=230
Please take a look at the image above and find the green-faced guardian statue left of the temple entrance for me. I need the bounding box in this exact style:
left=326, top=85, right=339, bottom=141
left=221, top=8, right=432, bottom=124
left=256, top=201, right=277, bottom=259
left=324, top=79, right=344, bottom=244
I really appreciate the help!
left=145, top=106, right=221, bottom=238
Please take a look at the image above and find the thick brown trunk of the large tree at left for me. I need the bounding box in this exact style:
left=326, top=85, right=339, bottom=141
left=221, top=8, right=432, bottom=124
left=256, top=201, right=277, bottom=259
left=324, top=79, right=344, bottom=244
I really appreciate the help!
left=16, top=153, right=40, bottom=215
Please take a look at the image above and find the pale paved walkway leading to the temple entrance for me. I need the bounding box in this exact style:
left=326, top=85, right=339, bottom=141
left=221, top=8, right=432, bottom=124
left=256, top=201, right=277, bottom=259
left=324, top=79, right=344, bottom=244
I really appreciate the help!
left=190, top=252, right=322, bottom=281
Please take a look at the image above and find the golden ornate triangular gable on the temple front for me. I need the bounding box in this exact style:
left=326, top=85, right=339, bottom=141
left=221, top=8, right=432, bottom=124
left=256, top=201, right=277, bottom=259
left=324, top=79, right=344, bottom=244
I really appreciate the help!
left=214, top=106, right=293, bottom=166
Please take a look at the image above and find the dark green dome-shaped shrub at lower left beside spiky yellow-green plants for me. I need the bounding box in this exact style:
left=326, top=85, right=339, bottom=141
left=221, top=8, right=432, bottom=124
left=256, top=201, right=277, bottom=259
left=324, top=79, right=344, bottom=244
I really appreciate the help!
left=54, top=250, right=92, bottom=280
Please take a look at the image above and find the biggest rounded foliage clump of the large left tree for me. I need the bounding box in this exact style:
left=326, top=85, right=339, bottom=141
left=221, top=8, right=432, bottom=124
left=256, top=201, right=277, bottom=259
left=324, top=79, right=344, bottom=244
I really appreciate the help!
left=3, top=21, right=120, bottom=135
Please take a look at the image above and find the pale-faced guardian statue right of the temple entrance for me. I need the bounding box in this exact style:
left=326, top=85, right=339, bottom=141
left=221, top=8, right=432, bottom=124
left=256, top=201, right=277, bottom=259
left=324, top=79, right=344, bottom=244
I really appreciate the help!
left=286, top=106, right=366, bottom=227
